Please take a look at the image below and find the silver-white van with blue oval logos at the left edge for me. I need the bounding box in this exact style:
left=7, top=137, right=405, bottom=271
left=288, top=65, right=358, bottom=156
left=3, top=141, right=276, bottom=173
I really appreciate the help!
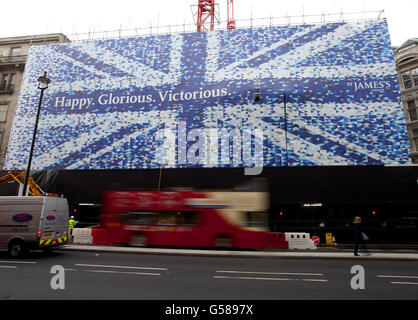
left=0, top=196, right=69, bottom=257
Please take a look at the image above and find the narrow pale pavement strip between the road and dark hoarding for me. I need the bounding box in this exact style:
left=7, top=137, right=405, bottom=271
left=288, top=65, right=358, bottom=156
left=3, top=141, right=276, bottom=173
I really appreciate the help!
left=56, top=244, right=418, bottom=261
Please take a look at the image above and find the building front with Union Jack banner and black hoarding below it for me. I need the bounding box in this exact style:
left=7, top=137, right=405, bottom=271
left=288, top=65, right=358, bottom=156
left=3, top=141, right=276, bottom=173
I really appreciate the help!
left=4, top=20, right=418, bottom=243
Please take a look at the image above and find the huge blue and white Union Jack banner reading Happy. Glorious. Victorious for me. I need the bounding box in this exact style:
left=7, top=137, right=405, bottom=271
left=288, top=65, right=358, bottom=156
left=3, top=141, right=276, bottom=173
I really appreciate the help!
left=5, top=20, right=410, bottom=170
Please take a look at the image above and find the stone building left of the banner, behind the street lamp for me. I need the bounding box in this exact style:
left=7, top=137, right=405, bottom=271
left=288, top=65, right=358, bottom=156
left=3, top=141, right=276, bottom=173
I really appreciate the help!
left=0, top=33, right=69, bottom=169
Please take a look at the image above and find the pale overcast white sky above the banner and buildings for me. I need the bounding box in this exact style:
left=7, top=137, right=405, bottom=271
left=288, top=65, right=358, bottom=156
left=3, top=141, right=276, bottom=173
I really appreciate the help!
left=0, top=0, right=418, bottom=46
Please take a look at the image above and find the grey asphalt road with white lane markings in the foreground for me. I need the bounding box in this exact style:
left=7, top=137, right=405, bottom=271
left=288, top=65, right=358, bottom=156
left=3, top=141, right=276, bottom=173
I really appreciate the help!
left=0, top=251, right=418, bottom=300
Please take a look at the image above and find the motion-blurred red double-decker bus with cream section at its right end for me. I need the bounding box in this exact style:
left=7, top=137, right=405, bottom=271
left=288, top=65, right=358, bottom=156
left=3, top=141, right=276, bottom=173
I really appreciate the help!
left=100, top=190, right=288, bottom=249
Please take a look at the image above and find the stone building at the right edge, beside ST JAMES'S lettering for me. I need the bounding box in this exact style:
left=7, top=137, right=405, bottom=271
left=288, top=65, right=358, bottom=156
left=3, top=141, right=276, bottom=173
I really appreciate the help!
left=394, top=38, right=418, bottom=164
